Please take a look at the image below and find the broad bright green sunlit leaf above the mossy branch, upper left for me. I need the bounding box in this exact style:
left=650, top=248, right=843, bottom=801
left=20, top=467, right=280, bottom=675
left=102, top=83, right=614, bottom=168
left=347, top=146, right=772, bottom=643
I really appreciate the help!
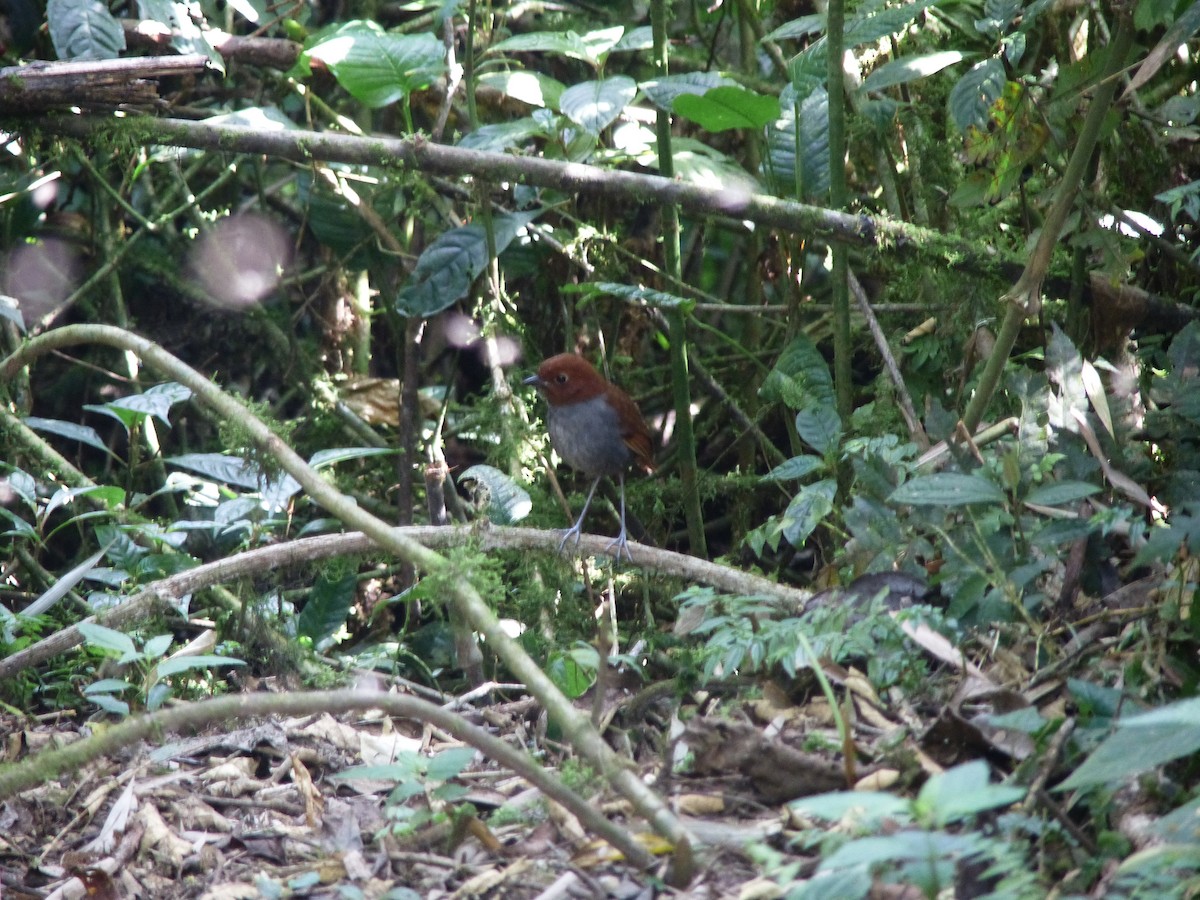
left=304, top=20, right=445, bottom=108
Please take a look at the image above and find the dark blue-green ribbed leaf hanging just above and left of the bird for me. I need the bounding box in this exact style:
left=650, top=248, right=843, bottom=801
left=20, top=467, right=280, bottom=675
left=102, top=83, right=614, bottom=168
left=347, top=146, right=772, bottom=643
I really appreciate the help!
left=396, top=212, right=540, bottom=318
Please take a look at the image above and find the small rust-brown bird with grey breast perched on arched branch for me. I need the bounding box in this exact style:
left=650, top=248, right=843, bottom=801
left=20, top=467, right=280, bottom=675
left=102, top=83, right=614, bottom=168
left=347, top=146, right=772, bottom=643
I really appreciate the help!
left=523, top=353, right=654, bottom=563
